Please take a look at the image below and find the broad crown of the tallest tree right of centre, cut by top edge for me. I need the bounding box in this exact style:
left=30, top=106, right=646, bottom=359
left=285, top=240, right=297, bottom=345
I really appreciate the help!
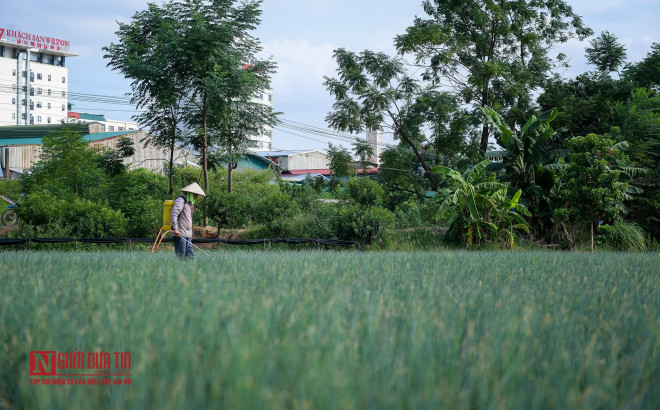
left=396, top=0, right=592, bottom=153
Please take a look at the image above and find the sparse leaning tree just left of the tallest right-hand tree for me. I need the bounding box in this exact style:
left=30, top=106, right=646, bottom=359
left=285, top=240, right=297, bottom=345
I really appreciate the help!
left=324, top=49, right=469, bottom=189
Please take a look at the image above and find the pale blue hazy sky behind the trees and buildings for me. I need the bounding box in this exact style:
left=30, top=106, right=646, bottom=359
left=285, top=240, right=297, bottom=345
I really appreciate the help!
left=0, top=0, right=660, bottom=149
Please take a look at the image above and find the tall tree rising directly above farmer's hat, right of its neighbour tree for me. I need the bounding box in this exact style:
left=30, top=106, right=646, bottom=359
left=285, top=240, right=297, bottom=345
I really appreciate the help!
left=177, top=0, right=275, bottom=195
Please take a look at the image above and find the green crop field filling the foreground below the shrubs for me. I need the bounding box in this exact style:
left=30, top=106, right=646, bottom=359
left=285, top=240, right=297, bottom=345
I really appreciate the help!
left=0, top=251, right=660, bottom=409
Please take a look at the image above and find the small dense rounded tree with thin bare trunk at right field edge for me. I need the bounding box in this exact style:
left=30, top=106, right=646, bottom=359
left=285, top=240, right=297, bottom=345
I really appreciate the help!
left=555, top=134, right=630, bottom=252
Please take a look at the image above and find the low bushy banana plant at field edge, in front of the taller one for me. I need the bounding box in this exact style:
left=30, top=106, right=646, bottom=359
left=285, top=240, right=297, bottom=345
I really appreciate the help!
left=432, top=160, right=530, bottom=246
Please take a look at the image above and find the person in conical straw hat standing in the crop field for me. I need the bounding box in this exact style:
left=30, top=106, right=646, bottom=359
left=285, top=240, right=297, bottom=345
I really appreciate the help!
left=170, top=182, right=206, bottom=258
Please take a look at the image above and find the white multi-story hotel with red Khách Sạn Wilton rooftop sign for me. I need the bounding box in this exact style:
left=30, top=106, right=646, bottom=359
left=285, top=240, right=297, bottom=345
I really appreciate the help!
left=0, top=27, right=75, bottom=126
